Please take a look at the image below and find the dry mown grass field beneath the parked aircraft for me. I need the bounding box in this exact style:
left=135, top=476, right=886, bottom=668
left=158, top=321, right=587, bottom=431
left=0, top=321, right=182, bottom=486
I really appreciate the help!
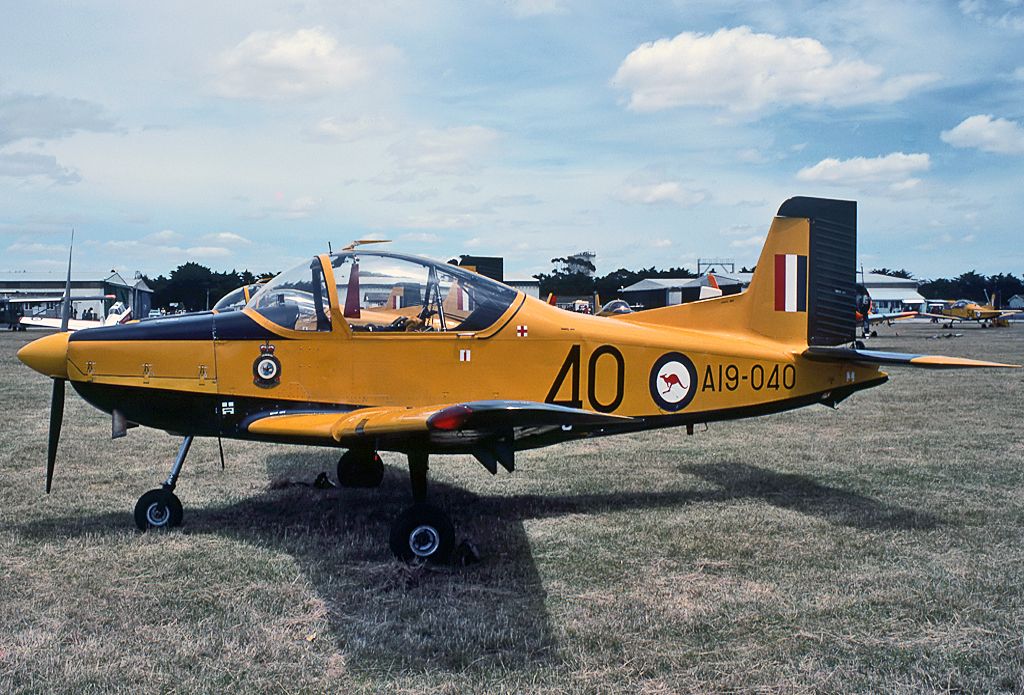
left=0, top=324, right=1024, bottom=693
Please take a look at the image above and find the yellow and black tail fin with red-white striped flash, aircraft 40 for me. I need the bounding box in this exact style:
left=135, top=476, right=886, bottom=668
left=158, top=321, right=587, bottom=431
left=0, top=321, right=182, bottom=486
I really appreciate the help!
left=622, top=198, right=857, bottom=345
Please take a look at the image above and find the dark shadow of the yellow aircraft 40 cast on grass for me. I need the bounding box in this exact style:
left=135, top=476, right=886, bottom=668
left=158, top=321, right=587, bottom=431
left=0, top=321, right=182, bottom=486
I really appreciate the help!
left=12, top=453, right=942, bottom=671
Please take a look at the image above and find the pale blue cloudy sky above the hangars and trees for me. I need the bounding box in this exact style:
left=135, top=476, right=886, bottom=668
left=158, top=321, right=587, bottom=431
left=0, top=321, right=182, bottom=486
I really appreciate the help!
left=0, top=0, right=1024, bottom=277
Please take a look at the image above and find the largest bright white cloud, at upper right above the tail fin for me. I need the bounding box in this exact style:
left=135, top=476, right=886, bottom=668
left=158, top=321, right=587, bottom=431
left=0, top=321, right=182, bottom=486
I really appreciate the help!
left=611, top=27, right=937, bottom=114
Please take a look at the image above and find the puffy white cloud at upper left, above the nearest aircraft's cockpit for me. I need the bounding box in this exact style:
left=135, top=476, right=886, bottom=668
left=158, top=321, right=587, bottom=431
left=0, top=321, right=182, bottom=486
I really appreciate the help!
left=214, top=27, right=387, bottom=99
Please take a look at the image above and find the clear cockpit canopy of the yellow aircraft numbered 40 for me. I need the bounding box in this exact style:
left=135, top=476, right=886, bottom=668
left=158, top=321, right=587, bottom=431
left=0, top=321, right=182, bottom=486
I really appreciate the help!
left=247, top=252, right=516, bottom=333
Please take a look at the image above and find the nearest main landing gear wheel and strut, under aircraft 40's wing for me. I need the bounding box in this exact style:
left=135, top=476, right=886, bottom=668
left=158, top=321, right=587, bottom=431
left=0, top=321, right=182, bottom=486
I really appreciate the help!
left=390, top=451, right=455, bottom=563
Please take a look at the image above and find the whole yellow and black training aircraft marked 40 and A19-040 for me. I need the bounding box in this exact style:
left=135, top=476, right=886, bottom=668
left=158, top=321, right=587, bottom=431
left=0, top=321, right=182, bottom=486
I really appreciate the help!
left=18, top=198, right=1010, bottom=560
